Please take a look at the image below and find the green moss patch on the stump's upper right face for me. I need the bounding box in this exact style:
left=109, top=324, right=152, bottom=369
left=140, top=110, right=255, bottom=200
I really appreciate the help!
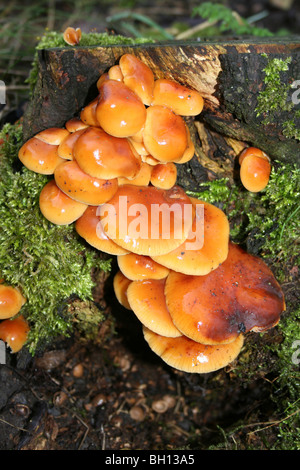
left=256, top=54, right=300, bottom=140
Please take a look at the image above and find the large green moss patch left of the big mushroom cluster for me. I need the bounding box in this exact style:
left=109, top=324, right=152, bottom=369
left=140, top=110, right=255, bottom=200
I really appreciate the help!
left=0, top=124, right=110, bottom=353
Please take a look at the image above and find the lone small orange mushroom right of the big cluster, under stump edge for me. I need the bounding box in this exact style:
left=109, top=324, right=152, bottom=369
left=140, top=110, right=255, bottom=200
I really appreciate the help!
left=239, top=147, right=271, bottom=193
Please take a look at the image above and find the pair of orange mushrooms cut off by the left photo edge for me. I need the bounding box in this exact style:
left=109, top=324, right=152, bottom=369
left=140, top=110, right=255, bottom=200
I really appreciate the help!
left=0, top=279, right=29, bottom=353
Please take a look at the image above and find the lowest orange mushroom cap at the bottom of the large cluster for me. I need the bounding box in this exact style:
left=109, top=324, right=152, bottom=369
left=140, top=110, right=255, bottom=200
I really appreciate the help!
left=143, top=327, right=244, bottom=374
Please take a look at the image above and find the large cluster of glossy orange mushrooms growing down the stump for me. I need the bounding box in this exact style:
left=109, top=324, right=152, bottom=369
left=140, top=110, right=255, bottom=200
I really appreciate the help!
left=19, top=54, right=285, bottom=373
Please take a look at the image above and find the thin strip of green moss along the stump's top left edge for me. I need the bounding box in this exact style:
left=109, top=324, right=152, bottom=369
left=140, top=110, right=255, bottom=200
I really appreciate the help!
left=27, top=31, right=154, bottom=92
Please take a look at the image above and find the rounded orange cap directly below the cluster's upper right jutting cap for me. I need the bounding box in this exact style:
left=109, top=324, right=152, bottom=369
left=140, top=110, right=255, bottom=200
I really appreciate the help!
left=143, top=106, right=188, bottom=163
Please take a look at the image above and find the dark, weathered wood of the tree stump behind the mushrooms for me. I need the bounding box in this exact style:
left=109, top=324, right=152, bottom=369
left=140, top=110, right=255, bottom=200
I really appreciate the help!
left=23, top=38, right=300, bottom=190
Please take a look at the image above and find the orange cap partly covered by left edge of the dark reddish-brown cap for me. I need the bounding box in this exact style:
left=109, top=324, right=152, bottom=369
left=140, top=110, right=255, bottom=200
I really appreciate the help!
left=127, top=279, right=182, bottom=338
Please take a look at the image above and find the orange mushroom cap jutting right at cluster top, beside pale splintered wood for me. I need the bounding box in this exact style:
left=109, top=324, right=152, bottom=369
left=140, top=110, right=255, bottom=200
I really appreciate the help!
left=152, top=78, right=204, bottom=116
